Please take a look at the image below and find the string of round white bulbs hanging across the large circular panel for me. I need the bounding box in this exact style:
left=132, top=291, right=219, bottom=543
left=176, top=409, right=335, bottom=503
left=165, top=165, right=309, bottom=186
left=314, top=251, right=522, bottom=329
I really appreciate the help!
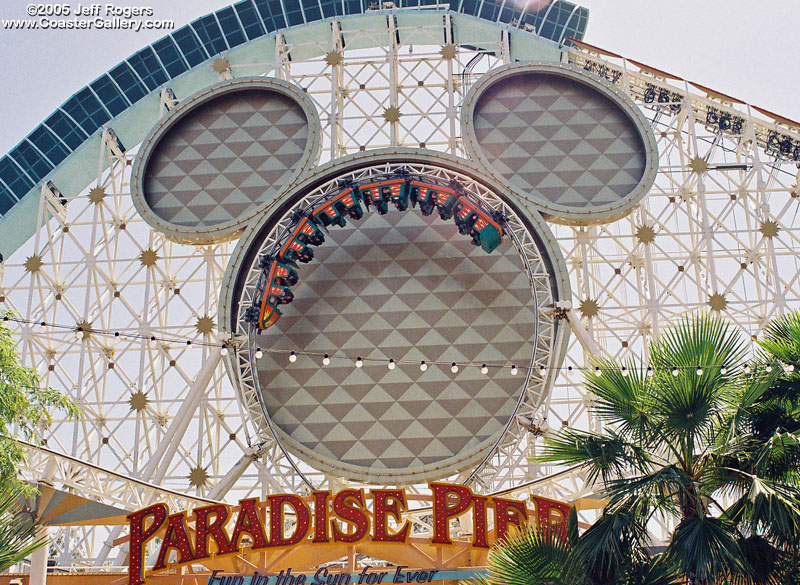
left=3, top=315, right=795, bottom=377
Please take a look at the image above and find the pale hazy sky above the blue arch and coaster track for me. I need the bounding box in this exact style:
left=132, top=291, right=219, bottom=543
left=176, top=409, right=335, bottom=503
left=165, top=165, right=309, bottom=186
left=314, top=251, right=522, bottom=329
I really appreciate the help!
left=0, top=0, right=800, bottom=153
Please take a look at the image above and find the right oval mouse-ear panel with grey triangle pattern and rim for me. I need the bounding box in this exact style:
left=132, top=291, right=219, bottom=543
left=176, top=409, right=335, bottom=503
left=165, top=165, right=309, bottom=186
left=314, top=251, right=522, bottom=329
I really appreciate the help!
left=461, top=64, right=658, bottom=224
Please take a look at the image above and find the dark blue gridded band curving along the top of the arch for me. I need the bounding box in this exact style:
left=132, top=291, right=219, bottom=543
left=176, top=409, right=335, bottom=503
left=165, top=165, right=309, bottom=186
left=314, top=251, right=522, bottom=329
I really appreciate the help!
left=0, top=0, right=588, bottom=246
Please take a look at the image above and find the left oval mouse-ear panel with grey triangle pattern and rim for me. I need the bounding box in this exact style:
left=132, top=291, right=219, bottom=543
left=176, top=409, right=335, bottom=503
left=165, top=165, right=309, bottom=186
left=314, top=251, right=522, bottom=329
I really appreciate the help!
left=131, top=78, right=321, bottom=243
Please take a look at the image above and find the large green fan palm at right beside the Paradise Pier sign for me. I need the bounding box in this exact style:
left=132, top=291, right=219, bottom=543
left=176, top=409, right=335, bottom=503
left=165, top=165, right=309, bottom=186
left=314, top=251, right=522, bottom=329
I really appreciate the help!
left=539, top=316, right=800, bottom=585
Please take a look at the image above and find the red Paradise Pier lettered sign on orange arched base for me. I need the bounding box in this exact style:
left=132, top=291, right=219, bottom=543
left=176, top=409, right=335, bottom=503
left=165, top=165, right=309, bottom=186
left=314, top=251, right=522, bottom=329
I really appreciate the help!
left=127, top=483, right=570, bottom=585
